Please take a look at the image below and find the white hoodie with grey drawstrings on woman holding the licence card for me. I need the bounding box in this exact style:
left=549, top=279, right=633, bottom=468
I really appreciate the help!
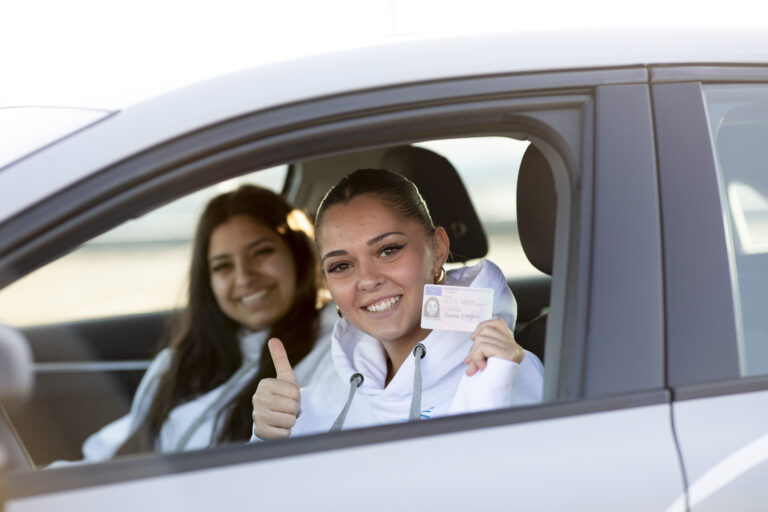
left=284, top=260, right=543, bottom=436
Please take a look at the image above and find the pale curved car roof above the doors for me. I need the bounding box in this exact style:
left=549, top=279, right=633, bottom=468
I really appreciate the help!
left=0, top=27, right=768, bottom=222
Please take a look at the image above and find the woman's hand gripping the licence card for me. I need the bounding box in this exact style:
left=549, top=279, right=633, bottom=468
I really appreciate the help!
left=464, top=318, right=525, bottom=377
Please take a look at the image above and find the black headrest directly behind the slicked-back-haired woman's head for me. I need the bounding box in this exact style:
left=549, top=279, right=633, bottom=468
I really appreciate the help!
left=382, top=146, right=488, bottom=263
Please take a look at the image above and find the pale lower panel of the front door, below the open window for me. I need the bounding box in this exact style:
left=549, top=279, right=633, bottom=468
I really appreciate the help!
left=7, top=398, right=683, bottom=512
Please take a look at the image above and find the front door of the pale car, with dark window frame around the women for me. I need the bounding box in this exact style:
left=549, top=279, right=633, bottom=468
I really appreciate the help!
left=0, top=67, right=684, bottom=512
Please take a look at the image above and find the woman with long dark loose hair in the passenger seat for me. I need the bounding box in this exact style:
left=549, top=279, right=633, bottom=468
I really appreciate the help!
left=78, top=185, right=336, bottom=460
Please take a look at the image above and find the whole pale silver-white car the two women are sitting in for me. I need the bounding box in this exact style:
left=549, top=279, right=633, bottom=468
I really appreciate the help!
left=0, top=28, right=768, bottom=512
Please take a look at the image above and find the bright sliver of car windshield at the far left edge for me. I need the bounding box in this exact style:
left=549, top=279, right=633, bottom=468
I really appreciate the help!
left=0, top=107, right=110, bottom=170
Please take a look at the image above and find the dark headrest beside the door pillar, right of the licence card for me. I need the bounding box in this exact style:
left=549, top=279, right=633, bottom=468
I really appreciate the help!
left=517, top=144, right=557, bottom=275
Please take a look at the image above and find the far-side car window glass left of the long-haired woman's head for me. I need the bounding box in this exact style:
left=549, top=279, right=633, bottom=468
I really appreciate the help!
left=0, top=165, right=287, bottom=327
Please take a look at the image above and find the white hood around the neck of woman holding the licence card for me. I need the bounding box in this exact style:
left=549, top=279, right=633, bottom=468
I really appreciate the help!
left=331, top=260, right=517, bottom=407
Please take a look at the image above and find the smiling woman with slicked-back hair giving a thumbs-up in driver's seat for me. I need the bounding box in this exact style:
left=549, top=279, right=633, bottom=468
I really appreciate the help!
left=253, top=169, right=543, bottom=439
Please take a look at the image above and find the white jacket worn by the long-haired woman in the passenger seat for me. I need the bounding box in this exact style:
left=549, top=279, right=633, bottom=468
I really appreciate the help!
left=67, top=306, right=336, bottom=465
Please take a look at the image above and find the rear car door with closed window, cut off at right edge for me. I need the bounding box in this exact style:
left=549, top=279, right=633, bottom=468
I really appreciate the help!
left=653, top=66, right=768, bottom=511
